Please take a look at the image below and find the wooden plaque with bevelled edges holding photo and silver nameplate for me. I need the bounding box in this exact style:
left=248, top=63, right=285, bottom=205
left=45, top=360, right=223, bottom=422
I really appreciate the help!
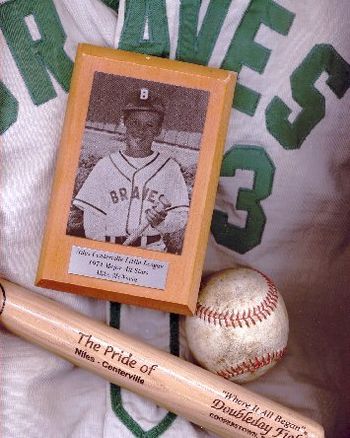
left=36, top=44, right=236, bottom=314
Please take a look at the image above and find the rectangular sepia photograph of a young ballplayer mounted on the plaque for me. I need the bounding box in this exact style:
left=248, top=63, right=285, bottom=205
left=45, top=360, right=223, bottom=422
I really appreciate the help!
left=66, top=72, right=209, bottom=254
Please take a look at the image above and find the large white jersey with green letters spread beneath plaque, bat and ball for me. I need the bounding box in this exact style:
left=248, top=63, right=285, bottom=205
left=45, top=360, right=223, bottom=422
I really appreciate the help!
left=0, top=0, right=350, bottom=438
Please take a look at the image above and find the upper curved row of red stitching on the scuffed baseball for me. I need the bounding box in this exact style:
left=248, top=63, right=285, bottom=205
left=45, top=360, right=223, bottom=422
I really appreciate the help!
left=195, top=271, right=278, bottom=328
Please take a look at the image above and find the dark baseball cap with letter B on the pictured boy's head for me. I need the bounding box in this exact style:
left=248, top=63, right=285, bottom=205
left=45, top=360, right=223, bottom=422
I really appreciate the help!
left=123, top=87, right=165, bottom=116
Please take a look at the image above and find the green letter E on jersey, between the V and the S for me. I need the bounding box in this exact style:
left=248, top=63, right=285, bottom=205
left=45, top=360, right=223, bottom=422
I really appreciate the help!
left=221, top=0, right=294, bottom=116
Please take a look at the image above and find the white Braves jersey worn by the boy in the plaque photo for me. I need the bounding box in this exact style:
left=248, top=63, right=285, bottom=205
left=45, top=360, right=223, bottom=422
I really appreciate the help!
left=73, top=151, right=189, bottom=249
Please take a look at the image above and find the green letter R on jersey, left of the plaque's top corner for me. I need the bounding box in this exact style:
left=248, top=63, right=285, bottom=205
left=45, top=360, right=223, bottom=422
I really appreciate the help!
left=0, top=0, right=73, bottom=105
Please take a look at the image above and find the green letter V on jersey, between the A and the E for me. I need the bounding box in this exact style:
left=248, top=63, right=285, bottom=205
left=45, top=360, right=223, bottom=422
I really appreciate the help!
left=176, top=0, right=231, bottom=65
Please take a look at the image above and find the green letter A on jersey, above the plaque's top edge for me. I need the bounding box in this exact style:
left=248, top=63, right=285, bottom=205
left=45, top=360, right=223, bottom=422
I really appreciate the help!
left=119, top=0, right=170, bottom=58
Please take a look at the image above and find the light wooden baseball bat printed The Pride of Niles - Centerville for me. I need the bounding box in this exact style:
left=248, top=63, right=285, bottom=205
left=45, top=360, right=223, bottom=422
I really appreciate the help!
left=0, top=280, right=324, bottom=438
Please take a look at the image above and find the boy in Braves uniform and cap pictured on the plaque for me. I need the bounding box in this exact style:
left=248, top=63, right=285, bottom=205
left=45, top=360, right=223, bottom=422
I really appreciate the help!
left=73, top=88, right=189, bottom=251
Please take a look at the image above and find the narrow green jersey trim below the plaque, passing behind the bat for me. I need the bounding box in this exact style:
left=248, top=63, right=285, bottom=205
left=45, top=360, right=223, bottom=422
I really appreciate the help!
left=110, top=303, right=180, bottom=438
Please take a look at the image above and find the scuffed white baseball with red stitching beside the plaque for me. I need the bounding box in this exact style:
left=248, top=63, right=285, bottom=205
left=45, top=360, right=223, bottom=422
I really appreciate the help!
left=185, top=267, right=289, bottom=383
